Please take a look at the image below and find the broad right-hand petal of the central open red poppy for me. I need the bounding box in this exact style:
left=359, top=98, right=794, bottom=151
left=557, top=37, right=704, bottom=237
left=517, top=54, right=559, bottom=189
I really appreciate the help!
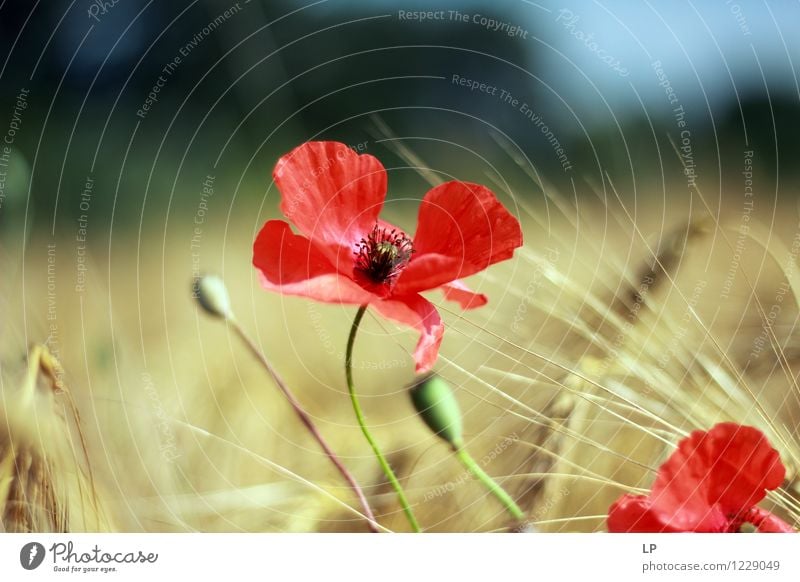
left=396, top=182, right=522, bottom=294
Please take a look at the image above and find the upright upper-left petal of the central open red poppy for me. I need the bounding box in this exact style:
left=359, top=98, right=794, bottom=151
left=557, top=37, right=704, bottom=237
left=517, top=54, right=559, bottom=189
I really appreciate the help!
left=272, top=141, right=386, bottom=250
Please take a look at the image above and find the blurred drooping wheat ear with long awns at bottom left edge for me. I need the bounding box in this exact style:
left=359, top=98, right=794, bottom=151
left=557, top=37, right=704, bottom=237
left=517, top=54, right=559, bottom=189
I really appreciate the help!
left=0, top=345, right=110, bottom=532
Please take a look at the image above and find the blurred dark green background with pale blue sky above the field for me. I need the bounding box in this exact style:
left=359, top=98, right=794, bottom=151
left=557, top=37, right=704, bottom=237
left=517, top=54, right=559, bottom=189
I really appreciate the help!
left=0, top=0, right=800, bottom=242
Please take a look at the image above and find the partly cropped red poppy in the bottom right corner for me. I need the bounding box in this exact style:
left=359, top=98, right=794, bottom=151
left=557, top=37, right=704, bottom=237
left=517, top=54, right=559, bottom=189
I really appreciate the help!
left=608, top=422, right=794, bottom=533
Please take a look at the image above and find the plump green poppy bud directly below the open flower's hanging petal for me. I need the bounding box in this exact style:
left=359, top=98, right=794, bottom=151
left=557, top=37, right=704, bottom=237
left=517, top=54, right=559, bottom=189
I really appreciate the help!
left=411, top=374, right=464, bottom=449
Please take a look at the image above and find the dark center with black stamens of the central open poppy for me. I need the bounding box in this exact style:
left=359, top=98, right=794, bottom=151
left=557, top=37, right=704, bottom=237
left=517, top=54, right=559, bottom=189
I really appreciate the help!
left=353, top=224, right=414, bottom=283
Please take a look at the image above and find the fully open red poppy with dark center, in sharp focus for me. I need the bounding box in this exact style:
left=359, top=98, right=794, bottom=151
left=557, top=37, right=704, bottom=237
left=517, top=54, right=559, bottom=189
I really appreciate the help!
left=253, top=142, right=522, bottom=372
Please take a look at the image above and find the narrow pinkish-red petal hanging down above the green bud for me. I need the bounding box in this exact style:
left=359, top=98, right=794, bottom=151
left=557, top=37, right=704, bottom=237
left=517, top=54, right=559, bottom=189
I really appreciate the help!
left=372, top=295, right=444, bottom=374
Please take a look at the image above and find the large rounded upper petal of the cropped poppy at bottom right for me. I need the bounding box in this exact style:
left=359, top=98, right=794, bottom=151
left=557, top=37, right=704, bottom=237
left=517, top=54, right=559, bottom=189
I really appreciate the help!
left=651, top=423, right=786, bottom=531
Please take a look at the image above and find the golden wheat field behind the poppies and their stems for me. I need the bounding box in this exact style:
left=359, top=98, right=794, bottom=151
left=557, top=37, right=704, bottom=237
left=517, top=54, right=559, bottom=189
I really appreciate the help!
left=6, top=157, right=800, bottom=532
